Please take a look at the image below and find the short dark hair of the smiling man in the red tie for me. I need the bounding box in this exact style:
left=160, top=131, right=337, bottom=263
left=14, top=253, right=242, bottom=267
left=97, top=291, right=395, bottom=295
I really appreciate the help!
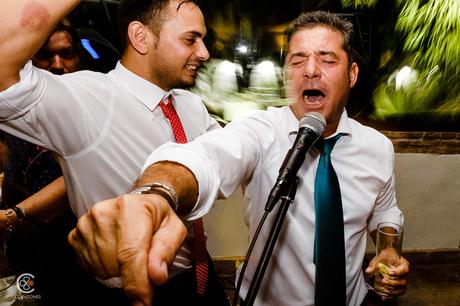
left=118, top=0, right=198, bottom=50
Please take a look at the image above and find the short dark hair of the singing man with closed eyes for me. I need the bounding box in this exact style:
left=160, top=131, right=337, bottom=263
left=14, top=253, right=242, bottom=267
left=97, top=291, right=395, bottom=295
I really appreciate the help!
left=285, top=11, right=353, bottom=64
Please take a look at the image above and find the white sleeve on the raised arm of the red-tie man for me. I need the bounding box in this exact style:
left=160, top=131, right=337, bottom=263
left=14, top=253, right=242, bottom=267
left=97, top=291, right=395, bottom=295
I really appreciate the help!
left=0, top=61, right=107, bottom=156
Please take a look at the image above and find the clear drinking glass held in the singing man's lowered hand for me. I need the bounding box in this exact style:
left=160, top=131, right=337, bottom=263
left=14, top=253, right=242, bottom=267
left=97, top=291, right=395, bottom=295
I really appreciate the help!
left=374, top=222, right=403, bottom=296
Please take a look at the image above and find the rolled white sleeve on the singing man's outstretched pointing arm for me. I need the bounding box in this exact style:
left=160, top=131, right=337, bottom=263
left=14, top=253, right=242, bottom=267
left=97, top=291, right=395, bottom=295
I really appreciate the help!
left=143, top=119, right=262, bottom=220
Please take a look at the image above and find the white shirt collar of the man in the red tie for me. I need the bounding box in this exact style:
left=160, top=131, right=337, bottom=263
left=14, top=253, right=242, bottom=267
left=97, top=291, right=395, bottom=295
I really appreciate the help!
left=110, top=61, right=174, bottom=111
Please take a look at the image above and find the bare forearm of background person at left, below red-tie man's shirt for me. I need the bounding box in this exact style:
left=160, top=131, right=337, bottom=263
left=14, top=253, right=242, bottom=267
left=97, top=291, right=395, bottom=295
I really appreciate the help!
left=17, top=176, right=68, bottom=222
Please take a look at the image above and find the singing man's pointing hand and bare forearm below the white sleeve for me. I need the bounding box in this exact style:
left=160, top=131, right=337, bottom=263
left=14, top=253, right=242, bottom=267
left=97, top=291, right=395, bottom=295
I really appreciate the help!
left=69, top=162, right=198, bottom=305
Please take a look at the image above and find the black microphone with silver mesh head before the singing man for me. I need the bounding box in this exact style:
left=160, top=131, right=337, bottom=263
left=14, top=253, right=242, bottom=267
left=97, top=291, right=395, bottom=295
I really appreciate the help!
left=265, top=112, right=326, bottom=212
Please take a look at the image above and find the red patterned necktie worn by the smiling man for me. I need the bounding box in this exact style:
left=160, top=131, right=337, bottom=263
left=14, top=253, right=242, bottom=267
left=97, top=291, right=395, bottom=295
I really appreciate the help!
left=160, top=96, right=208, bottom=295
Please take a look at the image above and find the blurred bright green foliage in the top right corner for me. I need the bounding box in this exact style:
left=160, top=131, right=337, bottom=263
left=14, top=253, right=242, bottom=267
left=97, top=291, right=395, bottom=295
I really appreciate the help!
left=373, top=0, right=460, bottom=120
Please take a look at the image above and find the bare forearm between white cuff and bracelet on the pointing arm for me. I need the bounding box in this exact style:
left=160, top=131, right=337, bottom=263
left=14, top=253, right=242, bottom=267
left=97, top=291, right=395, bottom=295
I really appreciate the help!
left=134, top=161, right=198, bottom=215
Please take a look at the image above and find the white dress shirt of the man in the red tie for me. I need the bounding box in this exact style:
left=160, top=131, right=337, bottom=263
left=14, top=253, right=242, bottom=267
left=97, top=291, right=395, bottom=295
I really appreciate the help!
left=0, top=62, right=219, bottom=275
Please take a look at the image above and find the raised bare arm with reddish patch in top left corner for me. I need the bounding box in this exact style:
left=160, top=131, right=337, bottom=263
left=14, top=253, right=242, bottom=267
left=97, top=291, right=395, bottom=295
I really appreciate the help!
left=0, top=0, right=80, bottom=90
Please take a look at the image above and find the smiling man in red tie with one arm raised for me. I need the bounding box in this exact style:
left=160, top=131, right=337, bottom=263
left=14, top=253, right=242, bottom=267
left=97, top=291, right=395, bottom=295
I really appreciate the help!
left=0, top=0, right=228, bottom=305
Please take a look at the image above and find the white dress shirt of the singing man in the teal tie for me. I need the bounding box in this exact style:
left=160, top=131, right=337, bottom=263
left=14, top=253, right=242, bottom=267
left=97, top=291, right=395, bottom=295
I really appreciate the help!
left=145, top=107, right=402, bottom=306
